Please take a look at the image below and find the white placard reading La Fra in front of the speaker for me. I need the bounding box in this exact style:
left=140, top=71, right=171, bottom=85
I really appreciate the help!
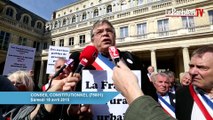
left=82, top=70, right=141, bottom=120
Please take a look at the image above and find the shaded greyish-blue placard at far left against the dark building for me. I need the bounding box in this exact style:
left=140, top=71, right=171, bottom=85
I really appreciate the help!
left=3, top=44, right=35, bottom=75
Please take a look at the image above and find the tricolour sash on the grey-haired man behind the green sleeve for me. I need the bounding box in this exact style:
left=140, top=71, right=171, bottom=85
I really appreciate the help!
left=157, top=94, right=176, bottom=118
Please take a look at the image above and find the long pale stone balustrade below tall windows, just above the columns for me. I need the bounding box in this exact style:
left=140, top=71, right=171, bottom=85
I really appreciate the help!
left=42, top=25, right=213, bottom=54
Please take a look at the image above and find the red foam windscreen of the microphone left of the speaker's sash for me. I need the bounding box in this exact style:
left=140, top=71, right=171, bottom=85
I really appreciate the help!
left=79, top=45, right=98, bottom=65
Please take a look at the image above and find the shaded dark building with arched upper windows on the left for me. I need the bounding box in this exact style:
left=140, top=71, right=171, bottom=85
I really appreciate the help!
left=0, top=0, right=48, bottom=86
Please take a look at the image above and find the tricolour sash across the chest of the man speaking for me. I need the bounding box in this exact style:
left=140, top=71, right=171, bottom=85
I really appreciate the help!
left=92, top=53, right=115, bottom=71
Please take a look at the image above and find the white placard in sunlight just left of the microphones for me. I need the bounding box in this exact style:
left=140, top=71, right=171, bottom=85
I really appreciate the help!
left=46, top=46, right=70, bottom=74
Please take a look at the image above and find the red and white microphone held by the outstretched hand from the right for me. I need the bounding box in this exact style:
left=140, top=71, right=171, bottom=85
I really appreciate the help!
left=108, top=46, right=120, bottom=65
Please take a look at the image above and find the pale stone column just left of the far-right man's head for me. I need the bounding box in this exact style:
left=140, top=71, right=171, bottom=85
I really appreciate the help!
left=182, top=47, right=190, bottom=72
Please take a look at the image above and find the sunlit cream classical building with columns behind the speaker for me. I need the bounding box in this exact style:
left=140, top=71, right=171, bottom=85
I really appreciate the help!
left=46, top=0, right=213, bottom=81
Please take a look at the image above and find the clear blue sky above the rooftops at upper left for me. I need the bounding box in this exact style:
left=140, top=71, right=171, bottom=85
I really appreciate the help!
left=11, top=0, right=77, bottom=20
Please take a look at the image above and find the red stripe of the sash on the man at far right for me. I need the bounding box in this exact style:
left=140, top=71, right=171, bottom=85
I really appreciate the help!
left=189, top=85, right=213, bottom=120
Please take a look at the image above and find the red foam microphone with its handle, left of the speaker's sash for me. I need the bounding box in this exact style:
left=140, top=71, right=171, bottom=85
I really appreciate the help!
left=74, top=45, right=98, bottom=73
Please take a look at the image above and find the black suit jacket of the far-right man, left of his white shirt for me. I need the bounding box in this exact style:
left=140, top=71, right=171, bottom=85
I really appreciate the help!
left=175, top=87, right=194, bottom=120
